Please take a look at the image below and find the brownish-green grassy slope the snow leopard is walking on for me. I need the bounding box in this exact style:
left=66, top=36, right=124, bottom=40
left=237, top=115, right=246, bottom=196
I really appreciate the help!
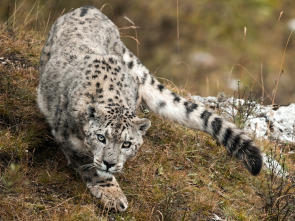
left=0, top=6, right=295, bottom=221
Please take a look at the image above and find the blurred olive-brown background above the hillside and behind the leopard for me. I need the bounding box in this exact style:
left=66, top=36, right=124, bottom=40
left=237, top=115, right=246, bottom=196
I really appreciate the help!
left=0, top=0, right=295, bottom=104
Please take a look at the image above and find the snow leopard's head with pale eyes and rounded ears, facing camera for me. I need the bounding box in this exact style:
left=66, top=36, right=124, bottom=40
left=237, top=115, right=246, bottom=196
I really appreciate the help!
left=84, top=105, right=150, bottom=175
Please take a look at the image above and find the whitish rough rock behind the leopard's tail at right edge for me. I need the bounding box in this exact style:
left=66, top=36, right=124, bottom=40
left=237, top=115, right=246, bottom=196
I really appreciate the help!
left=192, top=96, right=295, bottom=143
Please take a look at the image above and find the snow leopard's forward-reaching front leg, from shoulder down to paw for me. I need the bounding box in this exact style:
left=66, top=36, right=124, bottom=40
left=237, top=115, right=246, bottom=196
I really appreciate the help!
left=52, top=96, right=128, bottom=212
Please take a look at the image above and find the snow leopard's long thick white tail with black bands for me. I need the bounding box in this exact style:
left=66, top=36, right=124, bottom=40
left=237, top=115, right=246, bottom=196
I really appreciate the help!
left=123, top=48, right=262, bottom=175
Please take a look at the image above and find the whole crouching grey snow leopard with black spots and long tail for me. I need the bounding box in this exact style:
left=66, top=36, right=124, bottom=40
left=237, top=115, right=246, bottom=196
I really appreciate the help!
left=37, top=6, right=262, bottom=212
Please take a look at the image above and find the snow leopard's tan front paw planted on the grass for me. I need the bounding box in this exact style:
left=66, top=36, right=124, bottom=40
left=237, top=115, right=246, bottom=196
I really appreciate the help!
left=88, top=181, right=128, bottom=212
